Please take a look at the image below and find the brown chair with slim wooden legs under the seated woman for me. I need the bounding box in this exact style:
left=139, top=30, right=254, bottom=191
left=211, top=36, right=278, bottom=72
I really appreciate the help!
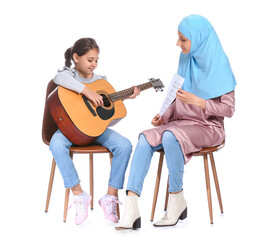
left=150, top=141, right=225, bottom=224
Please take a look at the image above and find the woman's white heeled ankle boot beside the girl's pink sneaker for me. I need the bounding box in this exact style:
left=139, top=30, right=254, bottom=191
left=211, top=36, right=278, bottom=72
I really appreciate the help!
left=115, top=195, right=141, bottom=230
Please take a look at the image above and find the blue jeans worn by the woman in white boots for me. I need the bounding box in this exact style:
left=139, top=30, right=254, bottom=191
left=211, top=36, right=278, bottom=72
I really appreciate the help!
left=127, top=131, right=184, bottom=196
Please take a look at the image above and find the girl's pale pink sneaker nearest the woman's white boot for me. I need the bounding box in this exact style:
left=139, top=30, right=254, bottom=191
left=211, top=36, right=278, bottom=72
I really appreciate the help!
left=99, top=194, right=122, bottom=223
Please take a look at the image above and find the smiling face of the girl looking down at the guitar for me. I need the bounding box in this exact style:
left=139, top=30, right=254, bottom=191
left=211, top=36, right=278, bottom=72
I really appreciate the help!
left=73, top=49, right=99, bottom=78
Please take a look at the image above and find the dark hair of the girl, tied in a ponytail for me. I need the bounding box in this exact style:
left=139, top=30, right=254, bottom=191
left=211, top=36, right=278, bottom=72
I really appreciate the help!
left=64, top=38, right=100, bottom=67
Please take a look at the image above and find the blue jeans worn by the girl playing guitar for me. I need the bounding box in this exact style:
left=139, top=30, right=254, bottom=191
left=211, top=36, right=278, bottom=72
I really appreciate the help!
left=49, top=128, right=132, bottom=189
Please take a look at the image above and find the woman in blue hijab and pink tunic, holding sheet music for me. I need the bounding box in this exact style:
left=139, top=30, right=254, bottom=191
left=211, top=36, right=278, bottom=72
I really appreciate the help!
left=116, top=15, right=236, bottom=230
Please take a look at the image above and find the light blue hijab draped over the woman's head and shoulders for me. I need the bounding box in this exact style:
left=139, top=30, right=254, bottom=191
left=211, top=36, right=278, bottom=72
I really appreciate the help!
left=177, top=15, right=236, bottom=100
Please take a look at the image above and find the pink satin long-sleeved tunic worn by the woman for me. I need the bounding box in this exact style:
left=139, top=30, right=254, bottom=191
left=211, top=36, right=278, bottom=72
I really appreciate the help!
left=142, top=91, right=235, bottom=164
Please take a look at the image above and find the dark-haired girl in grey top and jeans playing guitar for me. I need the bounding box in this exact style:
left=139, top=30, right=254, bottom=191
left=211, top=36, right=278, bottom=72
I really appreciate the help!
left=50, top=38, right=140, bottom=224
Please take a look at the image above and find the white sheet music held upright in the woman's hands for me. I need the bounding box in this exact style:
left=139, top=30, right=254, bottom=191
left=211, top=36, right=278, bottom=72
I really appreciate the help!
left=159, top=73, right=184, bottom=116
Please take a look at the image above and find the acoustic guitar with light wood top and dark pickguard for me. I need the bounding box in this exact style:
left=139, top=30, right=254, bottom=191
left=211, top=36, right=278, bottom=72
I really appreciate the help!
left=47, top=78, right=164, bottom=146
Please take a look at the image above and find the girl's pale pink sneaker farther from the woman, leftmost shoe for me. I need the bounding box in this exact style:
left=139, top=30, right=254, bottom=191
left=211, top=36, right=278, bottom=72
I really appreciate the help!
left=69, top=192, right=92, bottom=225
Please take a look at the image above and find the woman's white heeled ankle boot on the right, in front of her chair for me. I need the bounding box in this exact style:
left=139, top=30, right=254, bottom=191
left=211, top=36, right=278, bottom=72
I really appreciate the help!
left=153, top=191, right=187, bottom=227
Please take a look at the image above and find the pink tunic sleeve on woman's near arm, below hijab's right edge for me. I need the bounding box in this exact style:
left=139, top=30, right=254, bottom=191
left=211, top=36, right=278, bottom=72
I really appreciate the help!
left=205, top=91, right=235, bottom=117
